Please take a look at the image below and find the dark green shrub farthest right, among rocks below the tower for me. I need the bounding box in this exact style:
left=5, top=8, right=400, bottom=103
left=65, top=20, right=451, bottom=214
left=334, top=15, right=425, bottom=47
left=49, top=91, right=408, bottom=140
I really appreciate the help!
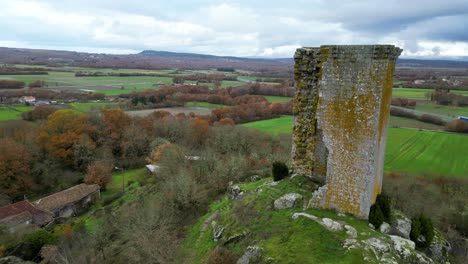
left=410, top=214, right=434, bottom=248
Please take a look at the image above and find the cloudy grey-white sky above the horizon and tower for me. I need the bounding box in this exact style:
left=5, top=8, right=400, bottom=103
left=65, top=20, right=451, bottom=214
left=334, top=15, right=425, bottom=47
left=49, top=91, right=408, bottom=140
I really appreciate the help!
left=0, top=0, right=468, bottom=58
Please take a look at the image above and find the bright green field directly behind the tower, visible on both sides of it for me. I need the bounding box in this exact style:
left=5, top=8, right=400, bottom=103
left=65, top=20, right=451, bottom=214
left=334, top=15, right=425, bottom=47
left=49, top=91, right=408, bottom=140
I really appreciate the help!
left=242, top=116, right=468, bottom=177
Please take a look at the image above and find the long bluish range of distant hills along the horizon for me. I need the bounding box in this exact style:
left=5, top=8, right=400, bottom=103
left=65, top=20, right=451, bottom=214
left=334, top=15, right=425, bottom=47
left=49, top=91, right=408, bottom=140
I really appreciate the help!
left=0, top=47, right=468, bottom=72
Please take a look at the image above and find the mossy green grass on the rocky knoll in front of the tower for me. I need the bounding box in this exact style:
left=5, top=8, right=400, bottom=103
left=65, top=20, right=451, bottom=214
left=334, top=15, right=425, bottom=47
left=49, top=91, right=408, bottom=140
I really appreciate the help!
left=176, top=177, right=374, bottom=263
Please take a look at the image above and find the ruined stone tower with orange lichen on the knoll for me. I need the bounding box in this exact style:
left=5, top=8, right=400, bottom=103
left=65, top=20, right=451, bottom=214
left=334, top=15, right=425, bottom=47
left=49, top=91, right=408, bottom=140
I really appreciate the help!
left=292, top=45, right=401, bottom=218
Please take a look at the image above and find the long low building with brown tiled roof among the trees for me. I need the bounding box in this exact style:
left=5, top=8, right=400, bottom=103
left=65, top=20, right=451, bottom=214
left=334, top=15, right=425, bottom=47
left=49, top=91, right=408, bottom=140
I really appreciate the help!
left=34, top=183, right=100, bottom=218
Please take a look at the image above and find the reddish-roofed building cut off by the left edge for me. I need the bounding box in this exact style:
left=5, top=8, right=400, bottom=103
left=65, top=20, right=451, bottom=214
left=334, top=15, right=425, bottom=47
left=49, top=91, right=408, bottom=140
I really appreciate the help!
left=0, top=201, right=52, bottom=231
